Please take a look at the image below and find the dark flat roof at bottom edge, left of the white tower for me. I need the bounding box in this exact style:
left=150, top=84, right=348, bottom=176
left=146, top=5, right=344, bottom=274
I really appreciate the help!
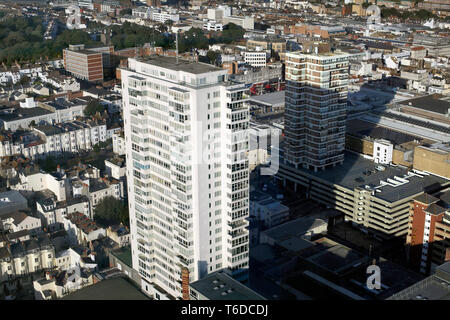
left=62, top=277, right=151, bottom=300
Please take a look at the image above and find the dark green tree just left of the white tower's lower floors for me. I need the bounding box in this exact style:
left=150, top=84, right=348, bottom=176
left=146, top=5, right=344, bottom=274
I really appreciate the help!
left=94, top=196, right=129, bottom=227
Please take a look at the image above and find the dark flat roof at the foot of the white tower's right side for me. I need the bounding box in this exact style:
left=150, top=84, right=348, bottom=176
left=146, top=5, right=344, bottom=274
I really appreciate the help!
left=190, top=271, right=266, bottom=300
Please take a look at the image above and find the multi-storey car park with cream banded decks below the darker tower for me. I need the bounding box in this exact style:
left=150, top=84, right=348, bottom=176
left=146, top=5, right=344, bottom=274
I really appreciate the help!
left=278, top=152, right=450, bottom=239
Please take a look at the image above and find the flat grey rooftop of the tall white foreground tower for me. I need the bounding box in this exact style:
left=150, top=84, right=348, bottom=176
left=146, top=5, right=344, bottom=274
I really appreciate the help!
left=136, top=56, right=224, bottom=74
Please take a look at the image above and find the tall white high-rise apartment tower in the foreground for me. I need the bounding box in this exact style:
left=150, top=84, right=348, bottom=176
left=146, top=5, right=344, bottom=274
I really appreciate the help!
left=121, top=56, right=249, bottom=299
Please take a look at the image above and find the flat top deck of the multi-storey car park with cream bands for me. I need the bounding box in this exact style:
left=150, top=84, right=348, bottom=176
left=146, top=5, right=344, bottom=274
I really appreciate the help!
left=280, top=152, right=450, bottom=203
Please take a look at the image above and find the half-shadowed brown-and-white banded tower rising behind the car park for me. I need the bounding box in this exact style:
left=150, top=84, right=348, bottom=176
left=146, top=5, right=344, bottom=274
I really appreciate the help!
left=285, top=52, right=348, bottom=171
